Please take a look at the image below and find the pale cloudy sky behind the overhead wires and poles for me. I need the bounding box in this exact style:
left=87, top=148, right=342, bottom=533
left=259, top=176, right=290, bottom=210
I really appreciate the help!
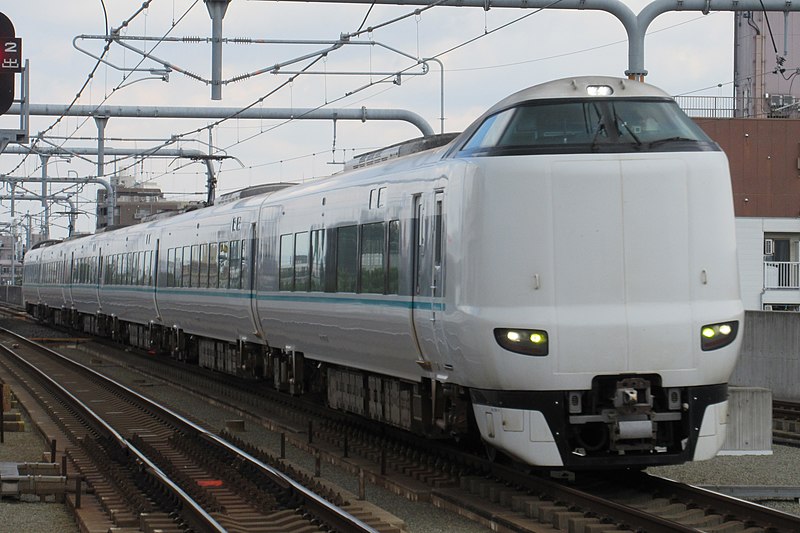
left=0, top=0, right=733, bottom=237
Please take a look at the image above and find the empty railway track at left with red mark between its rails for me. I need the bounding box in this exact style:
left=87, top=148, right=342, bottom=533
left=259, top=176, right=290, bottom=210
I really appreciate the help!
left=0, top=330, right=378, bottom=532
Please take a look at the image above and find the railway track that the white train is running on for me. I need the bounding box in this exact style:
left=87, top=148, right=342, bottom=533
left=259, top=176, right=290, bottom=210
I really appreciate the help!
left=1, top=308, right=800, bottom=532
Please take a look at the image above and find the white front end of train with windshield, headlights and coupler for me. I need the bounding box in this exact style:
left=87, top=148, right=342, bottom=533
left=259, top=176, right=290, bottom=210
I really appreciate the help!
left=448, top=77, right=743, bottom=468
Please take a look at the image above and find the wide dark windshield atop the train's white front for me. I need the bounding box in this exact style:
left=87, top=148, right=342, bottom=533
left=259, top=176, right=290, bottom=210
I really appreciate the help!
left=460, top=98, right=719, bottom=156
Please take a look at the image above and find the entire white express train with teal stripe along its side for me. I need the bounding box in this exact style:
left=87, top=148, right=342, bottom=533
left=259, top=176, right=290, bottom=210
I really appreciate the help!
left=24, top=77, right=743, bottom=468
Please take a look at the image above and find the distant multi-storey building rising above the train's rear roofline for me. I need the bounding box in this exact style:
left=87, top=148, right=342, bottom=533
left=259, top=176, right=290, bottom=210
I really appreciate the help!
left=97, top=178, right=203, bottom=231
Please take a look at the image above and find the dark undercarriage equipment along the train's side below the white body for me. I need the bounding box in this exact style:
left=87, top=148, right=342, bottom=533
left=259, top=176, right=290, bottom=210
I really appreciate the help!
left=28, top=305, right=474, bottom=438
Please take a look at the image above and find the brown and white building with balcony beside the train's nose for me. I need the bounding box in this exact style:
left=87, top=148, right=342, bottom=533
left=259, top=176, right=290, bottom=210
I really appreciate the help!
left=695, top=118, right=800, bottom=311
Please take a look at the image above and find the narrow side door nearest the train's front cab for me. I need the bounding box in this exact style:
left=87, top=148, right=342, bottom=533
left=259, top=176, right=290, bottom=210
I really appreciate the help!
left=412, top=189, right=447, bottom=360
